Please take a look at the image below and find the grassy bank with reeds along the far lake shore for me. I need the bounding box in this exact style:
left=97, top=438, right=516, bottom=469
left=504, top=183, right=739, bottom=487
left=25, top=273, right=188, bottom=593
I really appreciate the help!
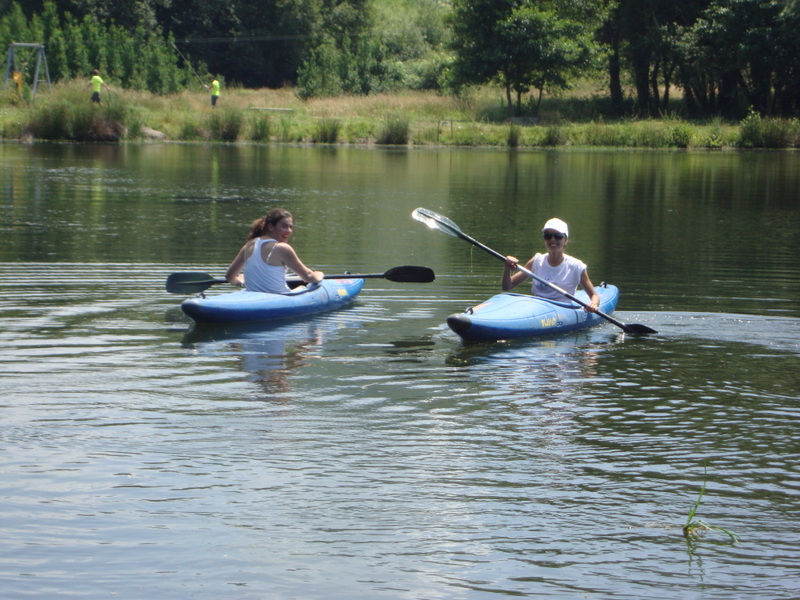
left=0, top=82, right=800, bottom=148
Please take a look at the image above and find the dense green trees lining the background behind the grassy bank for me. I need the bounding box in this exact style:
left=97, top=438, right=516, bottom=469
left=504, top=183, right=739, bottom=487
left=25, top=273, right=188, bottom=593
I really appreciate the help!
left=0, top=0, right=800, bottom=119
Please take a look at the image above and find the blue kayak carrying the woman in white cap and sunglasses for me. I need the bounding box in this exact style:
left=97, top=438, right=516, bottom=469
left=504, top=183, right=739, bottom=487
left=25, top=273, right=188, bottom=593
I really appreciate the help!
left=447, top=284, right=619, bottom=341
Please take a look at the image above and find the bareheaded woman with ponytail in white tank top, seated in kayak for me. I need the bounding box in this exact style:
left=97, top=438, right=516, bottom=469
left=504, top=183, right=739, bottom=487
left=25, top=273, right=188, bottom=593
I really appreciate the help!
left=225, top=208, right=324, bottom=294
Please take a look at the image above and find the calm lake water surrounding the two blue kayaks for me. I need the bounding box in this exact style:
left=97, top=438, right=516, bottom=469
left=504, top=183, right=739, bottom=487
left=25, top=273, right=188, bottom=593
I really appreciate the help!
left=0, top=144, right=800, bottom=600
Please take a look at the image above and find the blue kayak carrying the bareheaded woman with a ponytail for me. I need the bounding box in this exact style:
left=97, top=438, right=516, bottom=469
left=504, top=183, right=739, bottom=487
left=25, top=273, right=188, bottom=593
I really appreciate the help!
left=181, top=279, right=364, bottom=323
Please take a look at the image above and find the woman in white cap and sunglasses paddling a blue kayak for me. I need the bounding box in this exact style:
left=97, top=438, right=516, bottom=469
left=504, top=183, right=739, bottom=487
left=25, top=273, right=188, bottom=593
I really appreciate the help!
left=502, top=219, right=600, bottom=312
